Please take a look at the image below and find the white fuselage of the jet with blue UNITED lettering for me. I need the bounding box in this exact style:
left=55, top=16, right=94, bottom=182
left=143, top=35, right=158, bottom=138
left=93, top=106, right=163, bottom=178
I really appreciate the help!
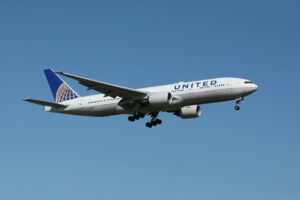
left=45, top=78, right=257, bottom=116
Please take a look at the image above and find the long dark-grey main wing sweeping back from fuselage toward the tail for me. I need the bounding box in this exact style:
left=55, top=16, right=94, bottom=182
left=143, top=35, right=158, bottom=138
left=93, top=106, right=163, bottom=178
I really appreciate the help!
left=56, top=72, right=147, bottom=99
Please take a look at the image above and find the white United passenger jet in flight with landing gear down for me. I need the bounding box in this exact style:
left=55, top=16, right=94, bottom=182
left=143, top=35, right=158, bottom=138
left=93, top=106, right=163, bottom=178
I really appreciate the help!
left=24, top=69, right=258, bottom=128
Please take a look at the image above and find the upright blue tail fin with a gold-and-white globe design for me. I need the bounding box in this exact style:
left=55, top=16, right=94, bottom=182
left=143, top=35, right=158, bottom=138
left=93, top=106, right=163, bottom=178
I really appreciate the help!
left=44, top=69, right=79, bottom=103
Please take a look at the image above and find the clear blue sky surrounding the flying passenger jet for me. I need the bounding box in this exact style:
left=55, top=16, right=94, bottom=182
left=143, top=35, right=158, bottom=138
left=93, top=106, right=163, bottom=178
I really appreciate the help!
left=0, top=1, right=300, bottom=200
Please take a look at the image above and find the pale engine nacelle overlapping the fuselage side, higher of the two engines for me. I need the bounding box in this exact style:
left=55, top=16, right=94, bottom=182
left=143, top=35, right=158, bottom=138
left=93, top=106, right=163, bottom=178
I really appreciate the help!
left=148, top=92, right=172, bottom=107
